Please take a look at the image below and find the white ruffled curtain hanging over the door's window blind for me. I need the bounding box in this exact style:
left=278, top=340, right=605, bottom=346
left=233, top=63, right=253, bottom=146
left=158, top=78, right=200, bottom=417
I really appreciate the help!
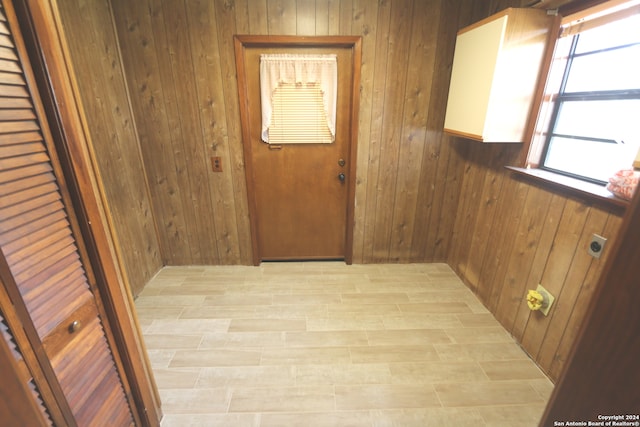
left=260, top=54, right=338, bottom=142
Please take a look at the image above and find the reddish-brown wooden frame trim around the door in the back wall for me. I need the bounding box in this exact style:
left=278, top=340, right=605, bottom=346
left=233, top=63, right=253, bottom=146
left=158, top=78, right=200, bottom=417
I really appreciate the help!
left=234, top=35, right=362, bottom=265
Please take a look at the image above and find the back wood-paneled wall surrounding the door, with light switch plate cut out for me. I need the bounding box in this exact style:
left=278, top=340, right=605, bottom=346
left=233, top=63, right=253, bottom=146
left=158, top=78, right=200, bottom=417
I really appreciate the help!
left=106, top=0, right=496, bottom=264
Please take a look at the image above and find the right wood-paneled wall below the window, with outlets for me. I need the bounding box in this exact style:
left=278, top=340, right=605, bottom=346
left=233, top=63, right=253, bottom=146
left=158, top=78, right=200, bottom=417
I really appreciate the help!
left=448, top=139, right=623, bottom=380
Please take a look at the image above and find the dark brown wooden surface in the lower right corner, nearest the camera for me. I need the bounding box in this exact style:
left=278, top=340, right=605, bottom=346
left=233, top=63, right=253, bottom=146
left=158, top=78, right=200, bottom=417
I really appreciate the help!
left=540, top=188, right=640, bottom=425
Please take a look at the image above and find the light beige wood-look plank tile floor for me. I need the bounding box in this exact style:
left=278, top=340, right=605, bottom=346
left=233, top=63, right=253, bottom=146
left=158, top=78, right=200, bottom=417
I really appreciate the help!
left=136, top=262, right=553, bottom=427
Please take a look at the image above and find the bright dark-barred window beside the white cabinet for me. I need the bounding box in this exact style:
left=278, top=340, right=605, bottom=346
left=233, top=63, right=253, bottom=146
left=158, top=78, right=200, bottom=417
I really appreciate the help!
left=540, top=7, right=640, bottom=184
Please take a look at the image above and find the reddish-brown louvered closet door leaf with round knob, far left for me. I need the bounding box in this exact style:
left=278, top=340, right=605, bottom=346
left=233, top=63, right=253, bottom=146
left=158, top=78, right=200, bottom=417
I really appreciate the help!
left=0, top=0, right=133, bottom=426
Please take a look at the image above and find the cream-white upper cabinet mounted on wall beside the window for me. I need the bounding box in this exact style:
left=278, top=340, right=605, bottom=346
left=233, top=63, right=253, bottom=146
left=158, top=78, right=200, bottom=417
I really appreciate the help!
left=444, top=8, right=559, bottom=142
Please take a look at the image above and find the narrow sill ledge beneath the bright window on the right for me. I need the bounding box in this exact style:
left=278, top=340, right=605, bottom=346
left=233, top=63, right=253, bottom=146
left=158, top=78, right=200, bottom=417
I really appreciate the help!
left=506, top=166, right=629, bottom=209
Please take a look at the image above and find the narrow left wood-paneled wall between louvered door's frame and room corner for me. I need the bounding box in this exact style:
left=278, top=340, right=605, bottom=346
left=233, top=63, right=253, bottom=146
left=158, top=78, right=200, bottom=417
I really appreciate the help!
left=57, top=0, right=162, bottom=295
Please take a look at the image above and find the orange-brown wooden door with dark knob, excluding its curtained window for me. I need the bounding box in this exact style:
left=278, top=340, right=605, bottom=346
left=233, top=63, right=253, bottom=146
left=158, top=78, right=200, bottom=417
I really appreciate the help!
left=238, top=36, right=359, bottom=262
